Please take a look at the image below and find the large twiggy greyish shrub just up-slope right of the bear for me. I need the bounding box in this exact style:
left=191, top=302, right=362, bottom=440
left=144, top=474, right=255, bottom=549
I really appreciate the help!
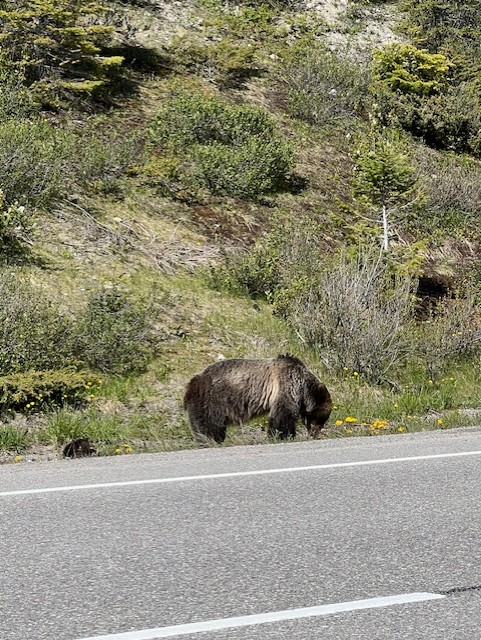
left=287, top=250, right=414, bottom=383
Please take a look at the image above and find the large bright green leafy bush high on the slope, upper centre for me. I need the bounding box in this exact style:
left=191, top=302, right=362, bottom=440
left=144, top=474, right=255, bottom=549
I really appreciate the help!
left=151, top=94, right=292, bottom=199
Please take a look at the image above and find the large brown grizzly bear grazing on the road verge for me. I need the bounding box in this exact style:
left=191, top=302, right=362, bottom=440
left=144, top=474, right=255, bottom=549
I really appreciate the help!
left=184, top=355, right=332, bottom=443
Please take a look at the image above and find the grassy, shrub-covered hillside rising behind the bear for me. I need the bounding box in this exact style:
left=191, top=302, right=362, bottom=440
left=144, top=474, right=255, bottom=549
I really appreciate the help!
left=0, top=0, right=481, bottom=461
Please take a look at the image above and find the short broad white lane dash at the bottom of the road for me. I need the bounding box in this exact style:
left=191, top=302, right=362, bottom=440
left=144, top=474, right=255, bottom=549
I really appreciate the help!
left=76, top=593, right=446, bottom=640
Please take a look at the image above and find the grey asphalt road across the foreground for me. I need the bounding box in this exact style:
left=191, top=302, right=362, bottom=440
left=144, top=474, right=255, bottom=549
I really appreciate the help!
left=0, top=429, right=481, bottom=640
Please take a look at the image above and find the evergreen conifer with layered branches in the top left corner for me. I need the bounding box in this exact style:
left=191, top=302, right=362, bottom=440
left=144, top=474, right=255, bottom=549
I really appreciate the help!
left=0, top=0, right=123, bottom=103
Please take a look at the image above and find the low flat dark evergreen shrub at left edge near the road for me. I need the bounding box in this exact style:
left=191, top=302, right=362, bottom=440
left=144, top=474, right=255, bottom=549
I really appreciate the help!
left=0, top=369, right=100, bottom=413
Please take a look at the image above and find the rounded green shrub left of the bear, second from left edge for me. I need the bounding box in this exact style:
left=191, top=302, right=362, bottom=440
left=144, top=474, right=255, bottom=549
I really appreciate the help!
left=74, top=288, right=154, bottom=373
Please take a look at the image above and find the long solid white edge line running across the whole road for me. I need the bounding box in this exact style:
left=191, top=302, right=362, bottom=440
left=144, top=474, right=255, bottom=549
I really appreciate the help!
left=0, top=451, right=481, bottom=498
